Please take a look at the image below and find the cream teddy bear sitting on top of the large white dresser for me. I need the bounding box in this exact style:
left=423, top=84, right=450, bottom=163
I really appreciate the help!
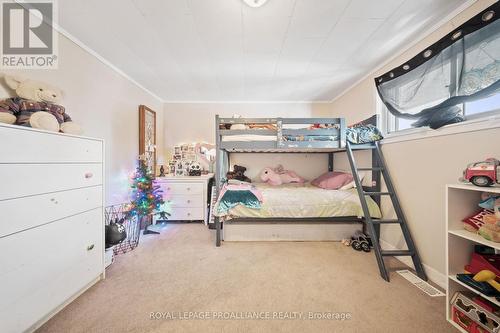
left=0, top=75, right=82, bottom=135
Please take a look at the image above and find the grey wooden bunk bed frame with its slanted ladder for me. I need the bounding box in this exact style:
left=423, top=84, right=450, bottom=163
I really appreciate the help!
left=215, top=115, right=427, bottom=281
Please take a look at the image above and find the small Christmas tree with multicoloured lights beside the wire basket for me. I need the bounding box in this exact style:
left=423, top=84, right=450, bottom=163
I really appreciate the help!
left=127, top=158, right=164, bottom=231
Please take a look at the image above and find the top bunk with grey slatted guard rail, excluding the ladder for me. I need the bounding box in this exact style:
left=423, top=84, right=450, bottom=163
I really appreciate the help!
left=215, top=116, right=346, bottom=153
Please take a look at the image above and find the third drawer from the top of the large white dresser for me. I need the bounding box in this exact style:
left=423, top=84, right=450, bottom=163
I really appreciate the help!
left=0, top=186, right=102, bottom=238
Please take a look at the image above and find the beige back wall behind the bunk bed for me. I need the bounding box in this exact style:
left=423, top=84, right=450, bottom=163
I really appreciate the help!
left=164, top=103, right=330, bottom=180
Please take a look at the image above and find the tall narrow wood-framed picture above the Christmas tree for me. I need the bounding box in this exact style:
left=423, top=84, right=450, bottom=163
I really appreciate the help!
left=139, top=105, right=156, bottom=176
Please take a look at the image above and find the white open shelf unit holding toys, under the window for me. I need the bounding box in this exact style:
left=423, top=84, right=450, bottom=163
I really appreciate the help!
left=446, top=184, right=500, bottom=332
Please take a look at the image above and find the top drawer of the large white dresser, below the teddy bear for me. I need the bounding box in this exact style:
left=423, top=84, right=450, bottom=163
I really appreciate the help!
left=0, top=126, right=103, bottom=163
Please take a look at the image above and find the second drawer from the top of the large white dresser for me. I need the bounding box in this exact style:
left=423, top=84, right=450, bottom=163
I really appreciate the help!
left=0, top=164, right=102, bottom=200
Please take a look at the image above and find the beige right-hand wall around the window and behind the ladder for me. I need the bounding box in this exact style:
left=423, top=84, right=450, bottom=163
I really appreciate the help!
left=332, top=0, right=500, bottom=282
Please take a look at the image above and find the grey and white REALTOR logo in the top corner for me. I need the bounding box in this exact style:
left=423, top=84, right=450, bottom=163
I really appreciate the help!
left=1, top=1, right=57, bottom=69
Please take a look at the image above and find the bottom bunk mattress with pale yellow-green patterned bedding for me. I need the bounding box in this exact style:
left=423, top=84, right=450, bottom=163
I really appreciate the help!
left=214, top=183, right=382, bottom=220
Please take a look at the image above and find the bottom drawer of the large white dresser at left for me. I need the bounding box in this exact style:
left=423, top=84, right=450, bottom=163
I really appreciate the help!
left=0, top=209, right=104, bottom=332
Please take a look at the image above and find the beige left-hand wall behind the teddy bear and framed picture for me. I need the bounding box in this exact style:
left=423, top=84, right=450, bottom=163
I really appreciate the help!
left=0, top=36, right=163, bottom=205
